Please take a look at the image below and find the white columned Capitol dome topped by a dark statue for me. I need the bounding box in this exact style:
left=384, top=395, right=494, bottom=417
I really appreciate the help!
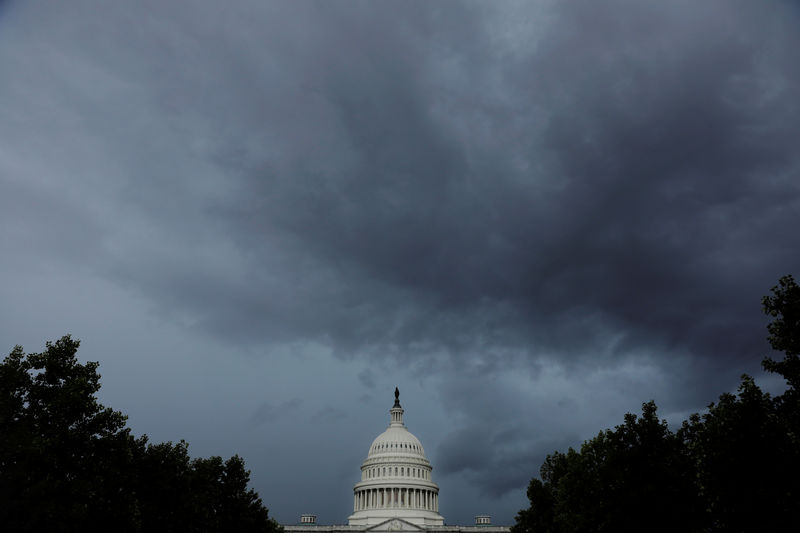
left=349, top=389, right=444, bottom=526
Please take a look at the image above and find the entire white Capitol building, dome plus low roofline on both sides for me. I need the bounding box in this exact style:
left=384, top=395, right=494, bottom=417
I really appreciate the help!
left=283, top=389, right=510, bottom=533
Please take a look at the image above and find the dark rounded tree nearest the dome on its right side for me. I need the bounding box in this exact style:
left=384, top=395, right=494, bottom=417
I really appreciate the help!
left=514, top=402, right=700, bottom=533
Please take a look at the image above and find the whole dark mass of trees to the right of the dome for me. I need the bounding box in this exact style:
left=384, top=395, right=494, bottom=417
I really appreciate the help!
left=512, top=276, right=800, bottom=533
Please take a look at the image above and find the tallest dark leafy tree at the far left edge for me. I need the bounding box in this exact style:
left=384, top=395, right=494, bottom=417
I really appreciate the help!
left=0, top=336, right=135, bottom=531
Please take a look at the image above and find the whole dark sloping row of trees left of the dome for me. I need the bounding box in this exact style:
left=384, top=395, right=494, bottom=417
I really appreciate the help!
left=0, top=336, right=281, bottom=533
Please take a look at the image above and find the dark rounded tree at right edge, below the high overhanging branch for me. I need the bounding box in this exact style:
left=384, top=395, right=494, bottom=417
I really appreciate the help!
left=679, top=376, right=800, bottom=532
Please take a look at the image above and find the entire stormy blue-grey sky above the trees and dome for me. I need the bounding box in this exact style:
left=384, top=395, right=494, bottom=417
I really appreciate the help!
left=0, top=0, right=800, bottom=524
